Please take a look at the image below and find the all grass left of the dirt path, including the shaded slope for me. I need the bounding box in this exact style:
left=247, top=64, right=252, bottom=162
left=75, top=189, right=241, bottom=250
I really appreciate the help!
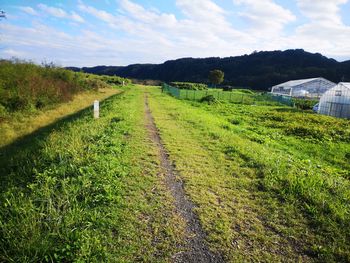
left=0, top=85, right=184, bottom=262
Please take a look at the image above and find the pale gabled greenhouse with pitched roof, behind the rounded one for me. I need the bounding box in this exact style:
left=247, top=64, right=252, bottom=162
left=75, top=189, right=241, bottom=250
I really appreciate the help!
left=271, top=78, right=336, bottom=99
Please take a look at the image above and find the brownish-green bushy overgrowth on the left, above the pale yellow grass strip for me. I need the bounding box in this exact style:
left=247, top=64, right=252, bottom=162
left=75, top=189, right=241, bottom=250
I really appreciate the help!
left=0, top=60, right=130, bottom=121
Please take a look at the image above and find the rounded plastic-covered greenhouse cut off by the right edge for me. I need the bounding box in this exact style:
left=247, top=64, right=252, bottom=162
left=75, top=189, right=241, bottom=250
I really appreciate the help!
left=318, top=82, right=350, bottom=119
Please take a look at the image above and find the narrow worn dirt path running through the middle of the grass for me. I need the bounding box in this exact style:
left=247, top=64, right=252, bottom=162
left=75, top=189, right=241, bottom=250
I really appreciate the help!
left=145, top=94, right=224, bottom=263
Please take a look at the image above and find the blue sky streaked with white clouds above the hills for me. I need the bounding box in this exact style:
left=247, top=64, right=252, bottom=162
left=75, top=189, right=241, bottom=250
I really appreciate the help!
left=0, top=0, right=350, bottom=67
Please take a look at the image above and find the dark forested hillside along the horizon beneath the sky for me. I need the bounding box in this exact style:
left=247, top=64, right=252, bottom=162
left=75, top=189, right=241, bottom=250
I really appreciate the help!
left=69, top=49, right=350, bottom=90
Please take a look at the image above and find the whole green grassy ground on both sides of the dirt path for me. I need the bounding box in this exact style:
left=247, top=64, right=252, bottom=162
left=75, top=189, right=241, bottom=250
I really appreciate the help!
left=0, top=86, right=350, bottom=262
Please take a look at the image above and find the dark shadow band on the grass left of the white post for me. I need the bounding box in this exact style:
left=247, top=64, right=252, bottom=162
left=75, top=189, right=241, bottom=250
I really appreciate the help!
left=0, top=93, right=122, bottom=193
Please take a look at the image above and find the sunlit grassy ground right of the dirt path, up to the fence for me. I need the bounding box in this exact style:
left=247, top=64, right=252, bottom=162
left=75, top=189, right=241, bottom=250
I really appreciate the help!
left=150, top=86, right=350, bottom=262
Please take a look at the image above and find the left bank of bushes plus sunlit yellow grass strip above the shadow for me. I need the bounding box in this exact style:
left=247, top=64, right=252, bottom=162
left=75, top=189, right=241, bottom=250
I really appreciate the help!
left=0, top=60, right=129, bottom=146
